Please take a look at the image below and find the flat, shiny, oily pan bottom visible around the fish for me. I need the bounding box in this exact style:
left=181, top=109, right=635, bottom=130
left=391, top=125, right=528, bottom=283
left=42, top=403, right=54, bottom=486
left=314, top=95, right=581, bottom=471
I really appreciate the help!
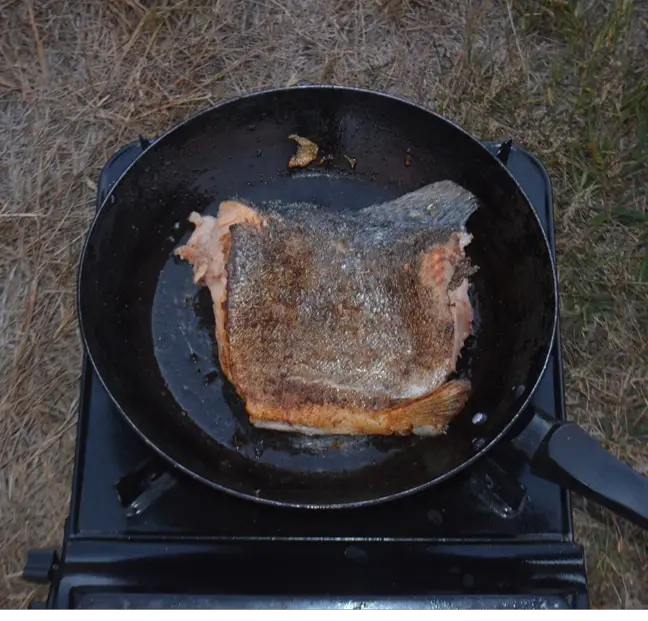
left=152, top=170, right=456, bottom=474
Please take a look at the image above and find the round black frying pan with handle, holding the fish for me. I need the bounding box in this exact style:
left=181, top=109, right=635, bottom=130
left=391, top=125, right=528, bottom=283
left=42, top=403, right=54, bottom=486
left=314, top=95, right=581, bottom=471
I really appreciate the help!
left=78, top=86, right=648, bottom=526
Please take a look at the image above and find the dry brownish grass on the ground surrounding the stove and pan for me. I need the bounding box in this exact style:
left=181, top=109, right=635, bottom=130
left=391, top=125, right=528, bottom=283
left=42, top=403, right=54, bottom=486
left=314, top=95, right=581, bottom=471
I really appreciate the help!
left=0, top=0, right=648, bottom=608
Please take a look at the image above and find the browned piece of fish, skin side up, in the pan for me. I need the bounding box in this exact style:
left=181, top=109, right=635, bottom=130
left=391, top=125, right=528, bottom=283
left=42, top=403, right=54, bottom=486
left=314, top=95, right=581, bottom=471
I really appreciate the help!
left=176, top=181, right=477, bottom=435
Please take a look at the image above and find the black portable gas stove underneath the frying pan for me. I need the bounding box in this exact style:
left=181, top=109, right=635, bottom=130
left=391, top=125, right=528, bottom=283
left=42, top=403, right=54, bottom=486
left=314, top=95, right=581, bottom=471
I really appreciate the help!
left=24, top=138, right=589, bottom=614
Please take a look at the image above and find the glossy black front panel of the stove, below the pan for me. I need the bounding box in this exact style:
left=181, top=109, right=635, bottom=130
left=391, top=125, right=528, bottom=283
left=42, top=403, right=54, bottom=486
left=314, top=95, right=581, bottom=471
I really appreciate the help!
left=28, top=541, right=589, bottom=611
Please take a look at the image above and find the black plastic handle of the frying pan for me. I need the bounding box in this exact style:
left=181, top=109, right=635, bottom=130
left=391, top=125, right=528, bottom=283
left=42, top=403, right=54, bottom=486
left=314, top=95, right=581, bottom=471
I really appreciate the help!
left=512, top=408, right=648, bottom=529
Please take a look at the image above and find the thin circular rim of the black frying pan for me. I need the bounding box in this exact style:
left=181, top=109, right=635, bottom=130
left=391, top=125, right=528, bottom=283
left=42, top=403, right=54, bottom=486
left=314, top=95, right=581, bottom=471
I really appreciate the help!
left=76, top=83, right=559, bottom=510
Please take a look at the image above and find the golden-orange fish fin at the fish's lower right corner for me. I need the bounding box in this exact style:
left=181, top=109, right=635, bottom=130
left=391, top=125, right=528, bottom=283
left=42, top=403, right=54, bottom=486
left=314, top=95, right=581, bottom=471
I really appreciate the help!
left=387, top=379, right=470, bottom=435
